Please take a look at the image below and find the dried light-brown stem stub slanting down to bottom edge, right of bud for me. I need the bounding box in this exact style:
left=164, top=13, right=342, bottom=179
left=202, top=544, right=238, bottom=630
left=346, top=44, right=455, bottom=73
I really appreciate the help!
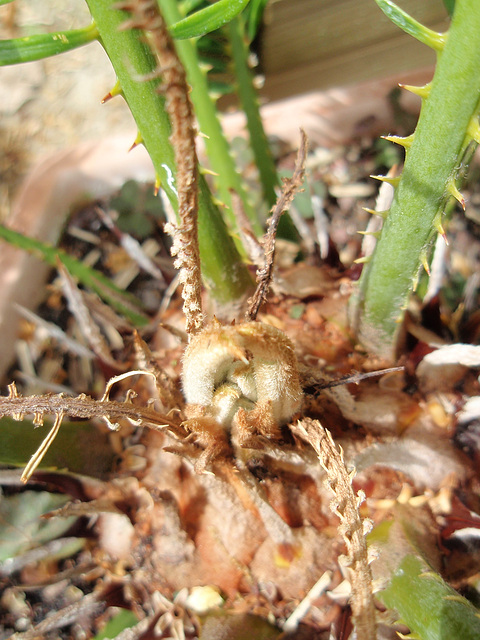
left=293, top=418, right=377, bottom=640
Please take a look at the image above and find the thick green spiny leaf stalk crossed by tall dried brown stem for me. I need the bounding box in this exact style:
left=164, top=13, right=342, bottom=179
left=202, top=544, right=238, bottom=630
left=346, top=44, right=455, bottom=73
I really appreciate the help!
left=87, top=0, right=252, bottom=304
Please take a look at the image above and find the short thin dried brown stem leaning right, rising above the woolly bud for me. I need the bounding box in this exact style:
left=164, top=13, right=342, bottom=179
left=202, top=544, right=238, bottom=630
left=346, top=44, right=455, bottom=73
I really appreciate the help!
left=245, top=129, right=308, bottom=322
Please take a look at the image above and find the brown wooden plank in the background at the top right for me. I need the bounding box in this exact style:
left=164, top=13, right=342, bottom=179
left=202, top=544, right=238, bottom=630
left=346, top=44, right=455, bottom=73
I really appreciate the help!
left=260, top=0, right=448, bottom=100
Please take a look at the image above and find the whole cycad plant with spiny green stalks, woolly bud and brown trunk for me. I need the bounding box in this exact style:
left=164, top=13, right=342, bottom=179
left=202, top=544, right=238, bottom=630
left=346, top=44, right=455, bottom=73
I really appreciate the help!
left=0, top=0, right=480, bottom=639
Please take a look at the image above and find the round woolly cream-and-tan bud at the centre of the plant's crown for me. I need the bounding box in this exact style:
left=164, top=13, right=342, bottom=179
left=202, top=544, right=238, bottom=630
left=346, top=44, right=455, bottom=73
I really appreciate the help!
left=182, top=320, right=302, bottom=435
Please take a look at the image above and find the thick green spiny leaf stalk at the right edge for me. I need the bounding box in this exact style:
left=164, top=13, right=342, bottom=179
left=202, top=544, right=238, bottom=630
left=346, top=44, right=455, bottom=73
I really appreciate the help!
left=350, top=0, right=480, bottom=359
